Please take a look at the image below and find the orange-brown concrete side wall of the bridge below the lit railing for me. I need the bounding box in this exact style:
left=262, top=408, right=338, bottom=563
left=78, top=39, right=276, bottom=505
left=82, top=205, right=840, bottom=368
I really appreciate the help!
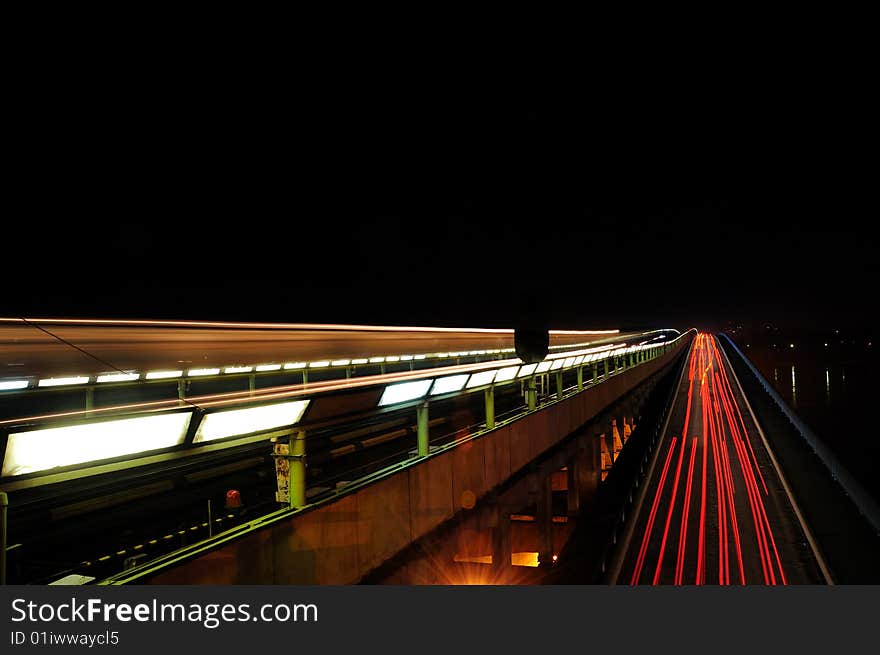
left=141, top=339, right=689, bottom=584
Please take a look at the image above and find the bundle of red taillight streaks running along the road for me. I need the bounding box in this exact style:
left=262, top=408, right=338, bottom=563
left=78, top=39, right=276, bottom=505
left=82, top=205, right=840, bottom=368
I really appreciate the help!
left=630, top=333, right=787, bottom=585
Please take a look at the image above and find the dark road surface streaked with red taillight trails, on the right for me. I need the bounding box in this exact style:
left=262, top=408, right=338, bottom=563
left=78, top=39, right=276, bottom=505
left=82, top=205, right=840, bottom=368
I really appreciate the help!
left=617, top=333, right=824, bottom=585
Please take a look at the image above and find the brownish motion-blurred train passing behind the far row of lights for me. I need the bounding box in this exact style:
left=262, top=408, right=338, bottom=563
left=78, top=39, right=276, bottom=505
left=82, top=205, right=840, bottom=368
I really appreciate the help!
left=0, top=319, right=640, bottom=378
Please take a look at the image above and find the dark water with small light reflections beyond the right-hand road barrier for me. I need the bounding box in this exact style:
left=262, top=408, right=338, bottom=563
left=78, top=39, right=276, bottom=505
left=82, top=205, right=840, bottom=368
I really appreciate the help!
left=727, top=326, right=880, bottom=500
